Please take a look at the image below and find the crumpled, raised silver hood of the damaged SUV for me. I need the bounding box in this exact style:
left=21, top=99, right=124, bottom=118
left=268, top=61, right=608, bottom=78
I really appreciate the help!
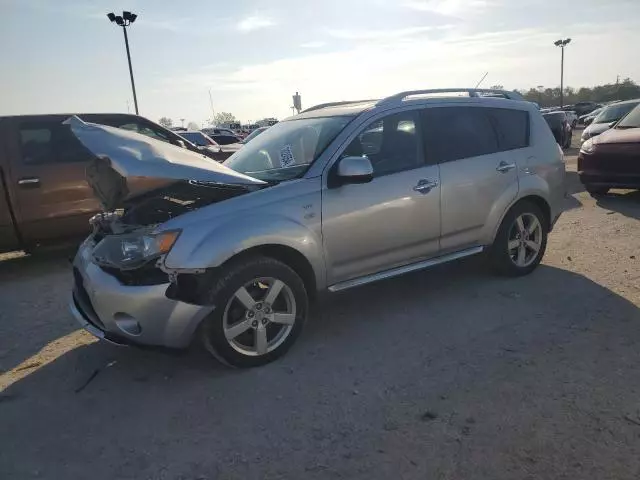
left=64, top=115, right=265, bottom=210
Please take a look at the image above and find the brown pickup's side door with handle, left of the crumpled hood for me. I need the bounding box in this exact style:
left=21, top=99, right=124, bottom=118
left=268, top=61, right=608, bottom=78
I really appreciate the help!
left=7, top=116, right=100, bottom=244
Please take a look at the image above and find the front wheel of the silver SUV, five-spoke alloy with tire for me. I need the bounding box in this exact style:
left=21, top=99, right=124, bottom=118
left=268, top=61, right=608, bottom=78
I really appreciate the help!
left=199, top=256, right=309, bottom=368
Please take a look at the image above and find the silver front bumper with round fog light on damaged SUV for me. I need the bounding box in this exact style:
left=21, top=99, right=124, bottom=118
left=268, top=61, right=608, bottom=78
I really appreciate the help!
left=69, top=242, right=213, bottom=348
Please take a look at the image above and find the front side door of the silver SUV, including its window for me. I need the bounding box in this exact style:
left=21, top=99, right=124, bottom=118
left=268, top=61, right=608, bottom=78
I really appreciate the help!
left=322, top=111, right=440, bottom=284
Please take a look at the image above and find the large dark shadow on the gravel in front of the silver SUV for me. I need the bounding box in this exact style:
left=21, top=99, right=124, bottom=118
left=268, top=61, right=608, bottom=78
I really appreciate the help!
left=0, top=258, right=640, bottom=480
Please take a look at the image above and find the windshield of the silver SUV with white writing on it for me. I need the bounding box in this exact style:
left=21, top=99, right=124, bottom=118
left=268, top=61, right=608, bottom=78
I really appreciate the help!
left=224, top=116, right=353, bottom=181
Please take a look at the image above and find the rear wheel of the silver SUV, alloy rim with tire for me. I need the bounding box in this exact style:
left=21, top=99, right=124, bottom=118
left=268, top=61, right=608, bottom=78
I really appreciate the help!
left=489, top=201, right=549, bottom=277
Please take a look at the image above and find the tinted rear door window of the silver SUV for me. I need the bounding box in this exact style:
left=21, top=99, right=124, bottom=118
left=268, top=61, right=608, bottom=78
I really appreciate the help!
left=422, top=107, right=500, bottom=163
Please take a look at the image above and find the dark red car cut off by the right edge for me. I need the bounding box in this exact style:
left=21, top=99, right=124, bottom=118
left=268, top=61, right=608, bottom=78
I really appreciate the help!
left=578, top=105, right=640, bottom=196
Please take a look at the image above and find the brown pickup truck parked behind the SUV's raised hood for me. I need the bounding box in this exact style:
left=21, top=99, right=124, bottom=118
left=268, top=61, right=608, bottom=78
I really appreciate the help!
left=0, top=113, right=207, bottom=252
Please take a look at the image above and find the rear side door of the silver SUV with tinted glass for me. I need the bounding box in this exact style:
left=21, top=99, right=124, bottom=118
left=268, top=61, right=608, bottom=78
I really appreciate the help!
left=422, top=106, right=528, bottom=253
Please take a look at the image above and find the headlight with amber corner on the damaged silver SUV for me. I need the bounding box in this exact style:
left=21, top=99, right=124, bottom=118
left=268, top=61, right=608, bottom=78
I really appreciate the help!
left=93, top=230, right=180, bottom=270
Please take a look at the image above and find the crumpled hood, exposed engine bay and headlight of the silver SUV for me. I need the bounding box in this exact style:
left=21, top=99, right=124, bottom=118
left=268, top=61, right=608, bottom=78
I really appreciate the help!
left=66, top=117, right=267, bottom=286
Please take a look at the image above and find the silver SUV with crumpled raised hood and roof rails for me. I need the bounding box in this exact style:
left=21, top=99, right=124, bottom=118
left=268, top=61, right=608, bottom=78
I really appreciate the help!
left=67, top=89, right=565, bottom=367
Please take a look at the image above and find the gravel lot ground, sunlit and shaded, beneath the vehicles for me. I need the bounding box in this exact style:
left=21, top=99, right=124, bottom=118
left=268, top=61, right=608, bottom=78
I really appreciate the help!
left=0, top=136, right=640, bottom=480
